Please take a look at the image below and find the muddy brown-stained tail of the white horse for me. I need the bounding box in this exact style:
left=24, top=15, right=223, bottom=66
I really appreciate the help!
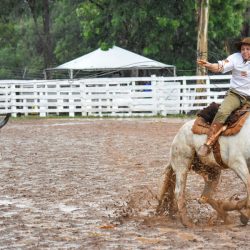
left=156, top=163, right=177, bottom=215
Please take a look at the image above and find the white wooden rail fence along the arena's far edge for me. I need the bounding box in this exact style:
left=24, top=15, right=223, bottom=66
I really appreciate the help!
left=0, top=75, right=231, bottom=117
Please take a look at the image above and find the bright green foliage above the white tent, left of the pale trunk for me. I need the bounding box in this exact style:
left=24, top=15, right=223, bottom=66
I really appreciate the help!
left=77, top=0, right=196, bottom=74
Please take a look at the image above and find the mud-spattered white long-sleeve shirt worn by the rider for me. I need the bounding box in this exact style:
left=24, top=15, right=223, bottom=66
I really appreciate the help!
left=218, top=53, right=250, bottom=96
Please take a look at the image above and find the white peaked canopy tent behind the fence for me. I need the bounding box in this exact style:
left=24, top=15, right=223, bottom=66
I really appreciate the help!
left=47, top=46, right=176, bottom=79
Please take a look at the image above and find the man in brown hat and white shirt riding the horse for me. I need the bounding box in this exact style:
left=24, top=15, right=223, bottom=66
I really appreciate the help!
left=197, top=37, right=250, bottom=157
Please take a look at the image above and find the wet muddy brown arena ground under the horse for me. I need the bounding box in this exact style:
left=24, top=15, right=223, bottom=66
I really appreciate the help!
left=0, top=118, right=250, bottom=249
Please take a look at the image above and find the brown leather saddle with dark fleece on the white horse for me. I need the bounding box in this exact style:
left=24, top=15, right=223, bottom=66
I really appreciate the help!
left=192, top=102, right=250, bottom=168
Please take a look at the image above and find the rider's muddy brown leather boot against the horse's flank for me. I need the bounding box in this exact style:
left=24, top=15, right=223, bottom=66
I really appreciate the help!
left=198, top=122, right=227, bottom=156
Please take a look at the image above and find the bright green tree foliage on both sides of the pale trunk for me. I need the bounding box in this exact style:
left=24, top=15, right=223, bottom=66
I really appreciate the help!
left=77, top=0, right=247, bottom=74
